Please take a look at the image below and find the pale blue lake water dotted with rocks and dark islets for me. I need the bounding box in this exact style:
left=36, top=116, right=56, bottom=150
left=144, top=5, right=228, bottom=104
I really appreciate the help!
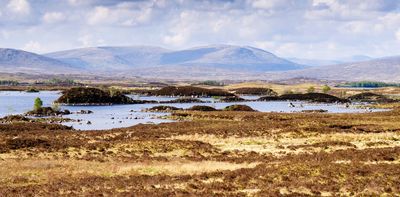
left=0, top=91, right=382, bottom=130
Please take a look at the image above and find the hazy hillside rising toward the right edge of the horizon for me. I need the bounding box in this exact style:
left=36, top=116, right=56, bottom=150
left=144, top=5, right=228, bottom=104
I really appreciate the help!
left=267, top=56, right=400, bottom=82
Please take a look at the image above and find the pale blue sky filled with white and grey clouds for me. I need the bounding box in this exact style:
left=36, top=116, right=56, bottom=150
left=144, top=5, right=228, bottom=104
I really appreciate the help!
left=0, top=0, right=400, bottom=59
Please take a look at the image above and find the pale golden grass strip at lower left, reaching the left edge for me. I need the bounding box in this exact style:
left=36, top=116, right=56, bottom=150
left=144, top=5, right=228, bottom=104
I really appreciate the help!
left=0, top=159, right=259, bottom=186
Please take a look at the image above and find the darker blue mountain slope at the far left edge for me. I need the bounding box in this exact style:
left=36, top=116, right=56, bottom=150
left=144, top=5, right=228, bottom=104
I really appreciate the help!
left=0, top=48, right=80, bottom=74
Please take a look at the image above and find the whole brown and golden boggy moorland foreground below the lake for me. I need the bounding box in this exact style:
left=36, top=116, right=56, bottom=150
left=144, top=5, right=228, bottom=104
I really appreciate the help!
left=0, top=104, right=400, bottom=196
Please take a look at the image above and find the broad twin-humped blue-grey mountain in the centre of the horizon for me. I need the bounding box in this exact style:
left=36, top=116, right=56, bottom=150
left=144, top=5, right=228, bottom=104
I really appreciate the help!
left=45, top=45, right=305, bottom=72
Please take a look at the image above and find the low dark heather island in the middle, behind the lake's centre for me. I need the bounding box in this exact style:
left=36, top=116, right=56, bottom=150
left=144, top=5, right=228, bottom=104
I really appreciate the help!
left=154, top=86, right=234, bottom=97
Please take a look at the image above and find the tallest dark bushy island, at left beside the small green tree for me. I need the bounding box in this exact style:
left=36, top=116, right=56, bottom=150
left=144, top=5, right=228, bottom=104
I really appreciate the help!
left=56, top=87, right=135, bottom=105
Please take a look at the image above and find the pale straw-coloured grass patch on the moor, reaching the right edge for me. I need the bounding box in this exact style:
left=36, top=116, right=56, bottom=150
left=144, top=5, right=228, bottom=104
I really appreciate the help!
left=170, top=132, right=400, bottom=156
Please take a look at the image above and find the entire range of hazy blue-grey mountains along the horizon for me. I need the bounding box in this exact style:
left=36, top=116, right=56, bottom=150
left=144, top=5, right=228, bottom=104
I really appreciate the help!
left=0, top=45, right=400, bottom=82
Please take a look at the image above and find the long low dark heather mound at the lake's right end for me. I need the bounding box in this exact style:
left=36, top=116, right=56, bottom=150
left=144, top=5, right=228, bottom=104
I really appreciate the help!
left=258, top=93, right=349, bottom=103
